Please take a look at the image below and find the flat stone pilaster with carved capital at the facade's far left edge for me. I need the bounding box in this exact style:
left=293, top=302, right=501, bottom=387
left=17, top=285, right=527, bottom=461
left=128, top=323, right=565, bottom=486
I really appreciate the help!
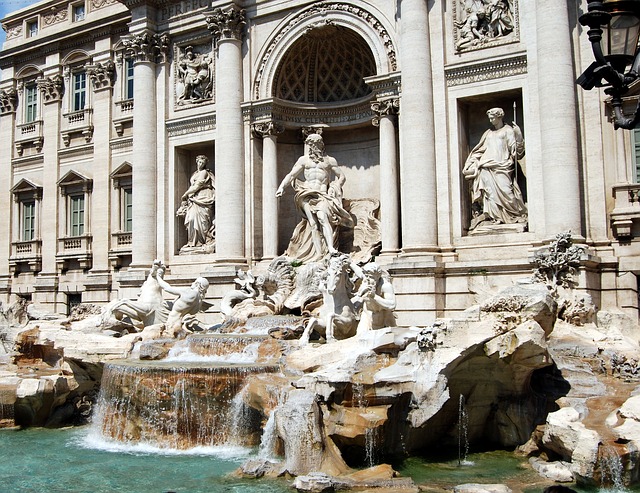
left=0, top=88, right=17, bottom=298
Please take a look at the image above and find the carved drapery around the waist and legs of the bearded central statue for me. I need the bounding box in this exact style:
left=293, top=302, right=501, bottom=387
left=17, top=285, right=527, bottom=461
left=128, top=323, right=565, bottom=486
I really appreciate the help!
left=285, top=180, right=354, bottom=262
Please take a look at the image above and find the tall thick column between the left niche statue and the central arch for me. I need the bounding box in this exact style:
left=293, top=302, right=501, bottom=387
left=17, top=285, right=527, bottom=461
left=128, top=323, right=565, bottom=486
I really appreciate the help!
left=206, top=4, right=245, bottom=262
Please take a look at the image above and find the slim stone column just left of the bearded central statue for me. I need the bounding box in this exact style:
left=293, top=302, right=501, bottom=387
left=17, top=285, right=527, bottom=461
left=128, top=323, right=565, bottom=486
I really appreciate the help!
left=253, top=121, right=284, bottom=260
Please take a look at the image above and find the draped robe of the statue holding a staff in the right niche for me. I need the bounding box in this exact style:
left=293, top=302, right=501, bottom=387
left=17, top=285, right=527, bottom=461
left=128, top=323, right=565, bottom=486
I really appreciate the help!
left=462, top=125, right=527, bottom=224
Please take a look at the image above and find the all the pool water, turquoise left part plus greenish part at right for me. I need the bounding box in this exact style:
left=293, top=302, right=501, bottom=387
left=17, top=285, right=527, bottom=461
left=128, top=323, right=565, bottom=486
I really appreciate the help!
left=0, top=427, right=640, bottom=493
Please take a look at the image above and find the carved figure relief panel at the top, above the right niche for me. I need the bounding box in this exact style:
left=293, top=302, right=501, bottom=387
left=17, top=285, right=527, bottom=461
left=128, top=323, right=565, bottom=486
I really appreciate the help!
left=454, top=0, right=515, bottom=51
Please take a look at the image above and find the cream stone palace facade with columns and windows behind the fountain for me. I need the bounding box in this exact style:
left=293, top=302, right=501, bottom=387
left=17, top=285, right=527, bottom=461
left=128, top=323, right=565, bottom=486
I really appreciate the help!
left=0, top=0, right=640, bottom=325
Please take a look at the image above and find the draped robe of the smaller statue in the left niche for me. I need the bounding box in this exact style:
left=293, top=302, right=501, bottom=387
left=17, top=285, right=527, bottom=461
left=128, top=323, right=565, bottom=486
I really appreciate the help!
left=184, top=170, right=216, bottom=247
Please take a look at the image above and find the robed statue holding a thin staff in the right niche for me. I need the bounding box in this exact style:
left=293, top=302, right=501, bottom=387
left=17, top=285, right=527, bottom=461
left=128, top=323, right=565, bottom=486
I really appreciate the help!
left=462, top=108, right=527, bottom=234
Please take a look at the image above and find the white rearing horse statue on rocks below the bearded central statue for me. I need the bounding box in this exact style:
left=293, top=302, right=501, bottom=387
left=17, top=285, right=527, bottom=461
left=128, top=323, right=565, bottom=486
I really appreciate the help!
left=300, top=252, right=358, bottom=345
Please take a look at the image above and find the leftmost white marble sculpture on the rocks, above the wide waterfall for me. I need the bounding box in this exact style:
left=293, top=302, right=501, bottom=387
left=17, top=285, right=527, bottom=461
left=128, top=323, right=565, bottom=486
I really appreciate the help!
left=100, top=260, right=167, bottom=330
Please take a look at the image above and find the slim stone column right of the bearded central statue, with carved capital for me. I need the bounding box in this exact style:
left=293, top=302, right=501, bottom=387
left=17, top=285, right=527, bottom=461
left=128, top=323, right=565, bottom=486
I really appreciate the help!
left=371, top=98, right=400, bottom=254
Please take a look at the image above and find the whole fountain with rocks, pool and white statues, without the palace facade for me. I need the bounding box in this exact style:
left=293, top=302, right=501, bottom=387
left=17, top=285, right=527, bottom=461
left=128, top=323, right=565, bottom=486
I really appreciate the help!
left=0, top=130, right=640, bottom=492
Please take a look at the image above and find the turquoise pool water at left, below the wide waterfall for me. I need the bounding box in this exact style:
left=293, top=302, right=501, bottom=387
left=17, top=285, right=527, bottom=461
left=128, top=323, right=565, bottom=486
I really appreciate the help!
left=0, top=427, right=291, bottom=493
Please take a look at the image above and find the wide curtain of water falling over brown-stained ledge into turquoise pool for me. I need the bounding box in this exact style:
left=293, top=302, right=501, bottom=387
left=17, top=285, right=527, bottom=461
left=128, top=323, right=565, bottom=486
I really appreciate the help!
left=94, top=362, right=277, bottom=449
